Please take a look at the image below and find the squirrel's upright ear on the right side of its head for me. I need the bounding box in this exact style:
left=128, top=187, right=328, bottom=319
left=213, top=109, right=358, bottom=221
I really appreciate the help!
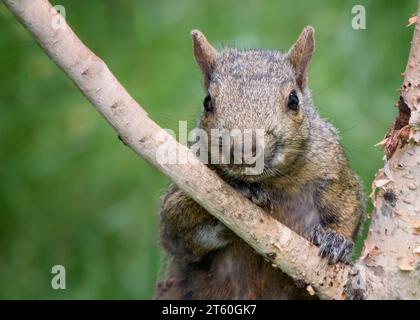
left=288, top=26, right=315, bottom=88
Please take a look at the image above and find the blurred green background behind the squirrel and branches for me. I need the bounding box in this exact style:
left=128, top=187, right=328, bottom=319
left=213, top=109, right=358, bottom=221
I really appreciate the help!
left=0, top=0, right=416, bottom=299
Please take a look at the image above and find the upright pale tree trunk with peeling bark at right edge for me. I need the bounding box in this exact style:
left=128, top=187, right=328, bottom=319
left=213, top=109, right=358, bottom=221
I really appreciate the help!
left=360, top=6, right=420, bottom=299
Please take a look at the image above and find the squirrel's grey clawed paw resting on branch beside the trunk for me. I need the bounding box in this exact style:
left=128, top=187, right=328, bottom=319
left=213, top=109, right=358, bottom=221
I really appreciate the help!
left=310, top=224, right=354, bottom=264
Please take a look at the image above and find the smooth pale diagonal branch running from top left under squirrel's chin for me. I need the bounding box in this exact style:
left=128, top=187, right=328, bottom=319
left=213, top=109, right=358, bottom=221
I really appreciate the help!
left=3, top=0, right=420, bottom=299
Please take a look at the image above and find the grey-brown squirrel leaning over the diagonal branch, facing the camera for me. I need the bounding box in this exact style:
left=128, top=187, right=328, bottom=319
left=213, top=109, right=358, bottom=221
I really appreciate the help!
left=155, top=26, right=364, bottom=299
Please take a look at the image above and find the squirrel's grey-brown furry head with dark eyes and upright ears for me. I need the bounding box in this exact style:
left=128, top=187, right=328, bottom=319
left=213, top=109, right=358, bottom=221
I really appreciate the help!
left=191, top=26, right=315, bottom=182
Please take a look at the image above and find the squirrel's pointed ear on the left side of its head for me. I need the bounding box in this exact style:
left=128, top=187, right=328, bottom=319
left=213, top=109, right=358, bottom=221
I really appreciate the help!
left=191, top=30, right=217, bottom=86
